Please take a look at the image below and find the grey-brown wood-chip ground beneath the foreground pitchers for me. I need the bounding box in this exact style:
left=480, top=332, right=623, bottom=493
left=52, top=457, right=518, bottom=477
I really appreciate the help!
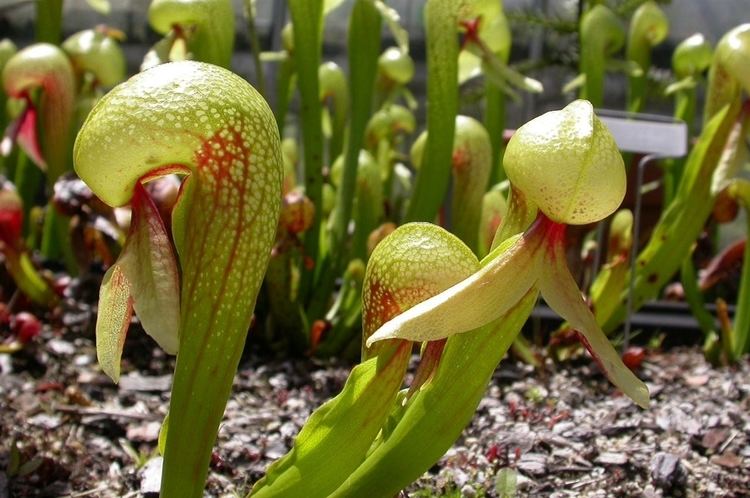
left=0, top=302, right=750, bottom=498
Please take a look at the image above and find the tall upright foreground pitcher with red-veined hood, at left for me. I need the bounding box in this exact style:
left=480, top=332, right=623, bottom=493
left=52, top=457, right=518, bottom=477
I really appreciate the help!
left=74, top=62, right=283, bottom=498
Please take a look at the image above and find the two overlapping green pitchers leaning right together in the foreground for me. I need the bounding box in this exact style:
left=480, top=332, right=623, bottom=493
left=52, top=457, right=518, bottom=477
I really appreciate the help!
left=253, top=101, right=648, bottom=497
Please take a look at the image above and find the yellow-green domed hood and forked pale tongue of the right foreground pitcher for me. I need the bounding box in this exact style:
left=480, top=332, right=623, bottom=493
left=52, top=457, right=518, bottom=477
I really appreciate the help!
left=366, top=101, right=648, bottom=406
